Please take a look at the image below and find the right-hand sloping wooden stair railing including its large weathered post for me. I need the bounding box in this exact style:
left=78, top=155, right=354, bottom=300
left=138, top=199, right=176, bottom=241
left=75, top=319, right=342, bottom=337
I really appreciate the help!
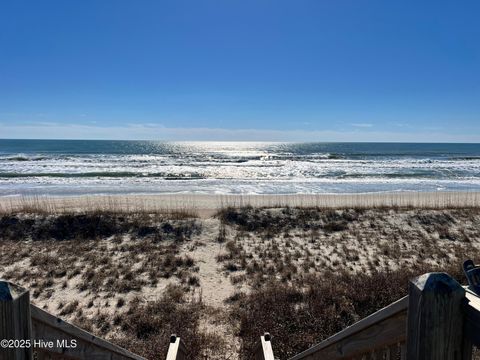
left=289, top=273, right=480, bottom=360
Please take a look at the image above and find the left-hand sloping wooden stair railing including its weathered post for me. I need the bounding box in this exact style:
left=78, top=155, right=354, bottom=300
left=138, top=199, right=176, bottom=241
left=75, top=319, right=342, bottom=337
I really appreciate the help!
left=0, top=280, right=145, bottom=360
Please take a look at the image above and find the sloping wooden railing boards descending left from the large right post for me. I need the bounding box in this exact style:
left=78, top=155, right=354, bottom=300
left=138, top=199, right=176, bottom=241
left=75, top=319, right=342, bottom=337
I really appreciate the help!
left=290, top=297, right=408, bottom=360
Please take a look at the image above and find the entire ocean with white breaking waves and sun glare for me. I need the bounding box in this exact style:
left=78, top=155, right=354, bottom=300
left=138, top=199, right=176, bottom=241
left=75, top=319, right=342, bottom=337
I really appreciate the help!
left=0, top=140, right=480, bottom=196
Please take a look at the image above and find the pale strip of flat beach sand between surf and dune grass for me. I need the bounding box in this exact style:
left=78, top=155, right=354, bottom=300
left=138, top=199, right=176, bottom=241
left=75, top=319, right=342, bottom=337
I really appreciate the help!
left=0, top=192, right=480, bottom=217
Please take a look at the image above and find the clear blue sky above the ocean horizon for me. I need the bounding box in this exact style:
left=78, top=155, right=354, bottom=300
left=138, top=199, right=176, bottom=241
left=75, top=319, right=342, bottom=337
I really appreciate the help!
left=0, top=0, right=480, bottom=142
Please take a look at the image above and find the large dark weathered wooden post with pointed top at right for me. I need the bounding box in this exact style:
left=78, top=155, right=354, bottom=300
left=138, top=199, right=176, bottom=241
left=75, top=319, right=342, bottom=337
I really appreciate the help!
left=407, top=273, right=470, bottom=360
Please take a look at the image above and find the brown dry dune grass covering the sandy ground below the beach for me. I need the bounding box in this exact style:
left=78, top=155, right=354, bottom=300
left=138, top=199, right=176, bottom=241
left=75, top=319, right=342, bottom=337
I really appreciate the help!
left=0, top=201, right=480, bottom=359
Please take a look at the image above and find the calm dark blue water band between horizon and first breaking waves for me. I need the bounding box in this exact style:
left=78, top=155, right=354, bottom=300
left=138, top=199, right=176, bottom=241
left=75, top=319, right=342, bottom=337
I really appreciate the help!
left=0, top=139, right=480, bottom=158
